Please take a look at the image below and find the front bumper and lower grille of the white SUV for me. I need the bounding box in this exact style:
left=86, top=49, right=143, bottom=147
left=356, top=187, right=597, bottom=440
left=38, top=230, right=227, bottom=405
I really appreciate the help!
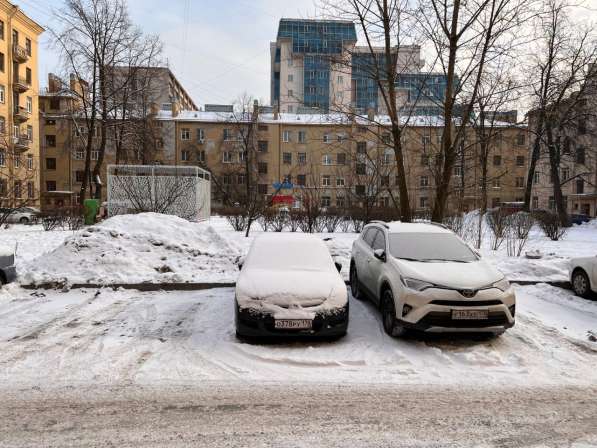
left=396, top=288, right=516, bottom=333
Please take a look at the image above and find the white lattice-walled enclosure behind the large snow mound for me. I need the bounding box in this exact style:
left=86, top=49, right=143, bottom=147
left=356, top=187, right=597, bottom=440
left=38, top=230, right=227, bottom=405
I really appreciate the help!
left=108, top=165, right=211, bottom=221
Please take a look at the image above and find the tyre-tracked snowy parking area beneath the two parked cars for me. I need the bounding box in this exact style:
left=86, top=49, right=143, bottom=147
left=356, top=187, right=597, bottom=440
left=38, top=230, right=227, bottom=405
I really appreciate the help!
left=0, top=285, right=597, bottom=387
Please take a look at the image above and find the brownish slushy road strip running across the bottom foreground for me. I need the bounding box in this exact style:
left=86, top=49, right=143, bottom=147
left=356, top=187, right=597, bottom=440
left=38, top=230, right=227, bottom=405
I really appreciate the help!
left=0, top=384, right=597, bottom=448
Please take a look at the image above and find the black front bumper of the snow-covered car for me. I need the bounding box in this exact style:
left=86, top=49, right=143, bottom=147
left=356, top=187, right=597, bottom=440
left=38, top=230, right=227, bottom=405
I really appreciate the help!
left=235, top=302, right=348, bottom=337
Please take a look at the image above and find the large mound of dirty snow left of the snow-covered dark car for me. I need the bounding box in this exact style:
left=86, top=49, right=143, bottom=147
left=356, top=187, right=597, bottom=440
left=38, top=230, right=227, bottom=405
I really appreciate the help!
left=19, top=213, right=240, bottom=284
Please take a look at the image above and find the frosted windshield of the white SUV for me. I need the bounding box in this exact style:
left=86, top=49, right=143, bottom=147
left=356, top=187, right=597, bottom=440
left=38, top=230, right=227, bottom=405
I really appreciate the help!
left=390, top=233, right=477, bottom=263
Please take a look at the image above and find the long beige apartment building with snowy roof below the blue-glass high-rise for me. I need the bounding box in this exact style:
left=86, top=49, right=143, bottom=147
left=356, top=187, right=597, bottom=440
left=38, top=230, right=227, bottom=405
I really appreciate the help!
left=165, top=107, right=527, bottom=213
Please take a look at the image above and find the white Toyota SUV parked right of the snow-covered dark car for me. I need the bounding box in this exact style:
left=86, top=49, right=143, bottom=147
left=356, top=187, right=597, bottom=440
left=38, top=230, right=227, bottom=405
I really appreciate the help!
left=350, top=221, right=516, bottom=336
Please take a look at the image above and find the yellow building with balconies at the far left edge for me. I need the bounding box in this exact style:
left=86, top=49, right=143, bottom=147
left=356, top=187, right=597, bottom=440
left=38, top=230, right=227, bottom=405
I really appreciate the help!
left=0, top=0, right=44, bottom=207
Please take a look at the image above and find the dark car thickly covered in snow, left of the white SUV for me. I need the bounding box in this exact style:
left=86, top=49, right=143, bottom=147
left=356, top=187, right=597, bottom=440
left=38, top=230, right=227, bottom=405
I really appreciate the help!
left=235, top=233, right=348, bottom=337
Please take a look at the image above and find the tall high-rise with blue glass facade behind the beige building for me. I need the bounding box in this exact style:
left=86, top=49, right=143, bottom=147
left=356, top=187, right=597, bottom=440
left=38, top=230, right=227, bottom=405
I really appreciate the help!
left=270, top=19, right=438, bottom=115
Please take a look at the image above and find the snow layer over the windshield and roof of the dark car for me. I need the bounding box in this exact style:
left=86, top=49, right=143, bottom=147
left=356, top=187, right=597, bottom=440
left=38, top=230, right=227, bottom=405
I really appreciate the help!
left=244, top=233, right=334, bottom=271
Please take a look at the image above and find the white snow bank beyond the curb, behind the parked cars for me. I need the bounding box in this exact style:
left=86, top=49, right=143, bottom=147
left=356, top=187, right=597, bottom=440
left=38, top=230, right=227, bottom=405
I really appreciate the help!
left=0, top=214, right=597, bottom=284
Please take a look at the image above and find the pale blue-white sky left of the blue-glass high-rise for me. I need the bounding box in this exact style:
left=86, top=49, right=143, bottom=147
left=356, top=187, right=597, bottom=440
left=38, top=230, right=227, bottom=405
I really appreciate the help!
left=12, top=0, right=315, bottom=105
